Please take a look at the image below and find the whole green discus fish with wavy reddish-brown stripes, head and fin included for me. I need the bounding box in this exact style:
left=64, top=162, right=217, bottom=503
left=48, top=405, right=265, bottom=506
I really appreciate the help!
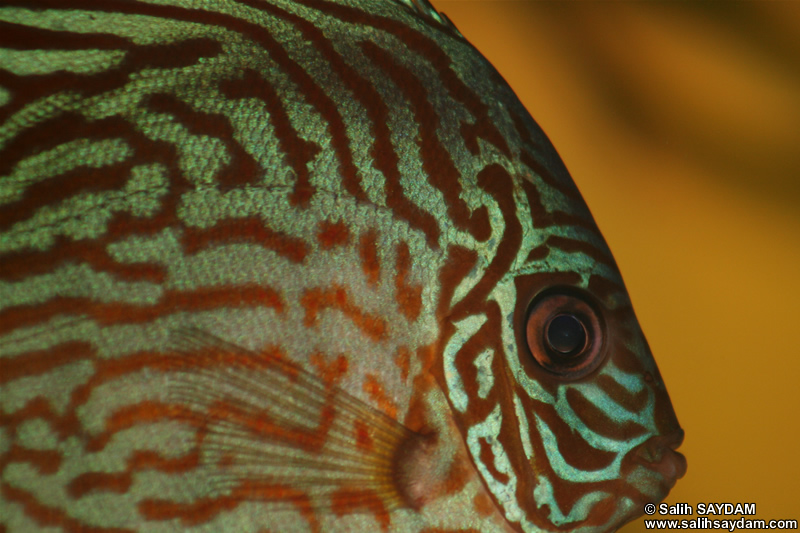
left=0, top=0, right=685, bottom=532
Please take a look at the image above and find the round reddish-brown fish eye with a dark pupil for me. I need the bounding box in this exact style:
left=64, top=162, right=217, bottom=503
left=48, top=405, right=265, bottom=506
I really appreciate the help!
left=526, top=290, right=604, bottom=379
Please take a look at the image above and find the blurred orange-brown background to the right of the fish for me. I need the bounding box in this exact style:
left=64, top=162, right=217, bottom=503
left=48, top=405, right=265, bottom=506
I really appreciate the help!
left=433, top=0, right=800, bottom=533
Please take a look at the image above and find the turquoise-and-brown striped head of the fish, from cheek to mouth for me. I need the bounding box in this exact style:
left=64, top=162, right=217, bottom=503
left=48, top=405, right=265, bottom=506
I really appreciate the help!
left=443, top=100, right=686, bottom=532
